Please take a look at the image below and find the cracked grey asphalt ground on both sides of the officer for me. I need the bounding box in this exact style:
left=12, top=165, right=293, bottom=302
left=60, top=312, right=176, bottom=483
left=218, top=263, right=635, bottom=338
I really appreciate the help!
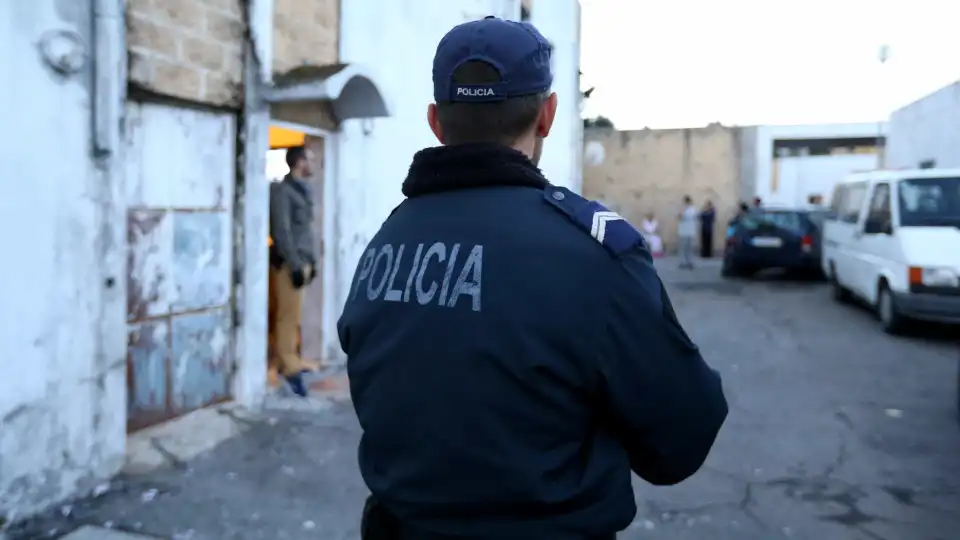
left=8, top=260, right=960, bottom=540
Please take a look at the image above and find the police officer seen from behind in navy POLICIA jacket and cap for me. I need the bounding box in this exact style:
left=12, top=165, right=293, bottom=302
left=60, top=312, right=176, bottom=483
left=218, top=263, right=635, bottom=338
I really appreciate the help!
left=338, top=17, right=727, bottom=540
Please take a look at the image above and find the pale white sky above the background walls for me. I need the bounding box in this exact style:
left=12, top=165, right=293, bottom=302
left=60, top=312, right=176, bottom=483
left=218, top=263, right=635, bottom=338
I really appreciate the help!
left=576, top=0, right=960, bottom=129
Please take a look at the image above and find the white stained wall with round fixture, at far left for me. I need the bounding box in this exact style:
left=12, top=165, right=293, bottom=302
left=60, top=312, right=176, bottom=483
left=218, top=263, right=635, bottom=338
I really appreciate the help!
left=0, top=0, right=126, bottom=518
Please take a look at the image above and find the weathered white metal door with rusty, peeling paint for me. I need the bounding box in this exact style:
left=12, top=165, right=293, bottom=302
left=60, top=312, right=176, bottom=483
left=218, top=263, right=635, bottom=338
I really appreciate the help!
left=125, top=103, right=236, bottom=430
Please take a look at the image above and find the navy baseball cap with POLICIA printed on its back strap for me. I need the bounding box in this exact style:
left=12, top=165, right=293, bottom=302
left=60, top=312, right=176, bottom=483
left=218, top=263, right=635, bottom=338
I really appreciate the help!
left=433, top=16, right=553, bottom=102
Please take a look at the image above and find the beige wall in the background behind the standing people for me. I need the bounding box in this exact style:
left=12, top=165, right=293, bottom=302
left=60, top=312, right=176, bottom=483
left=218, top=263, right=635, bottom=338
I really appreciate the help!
left=583, top=125, right=740, bottom=252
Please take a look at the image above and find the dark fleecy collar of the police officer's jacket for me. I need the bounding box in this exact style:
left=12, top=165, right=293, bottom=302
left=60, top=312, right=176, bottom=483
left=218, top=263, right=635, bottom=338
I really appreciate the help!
left=403, top=143, right=550, bottom=197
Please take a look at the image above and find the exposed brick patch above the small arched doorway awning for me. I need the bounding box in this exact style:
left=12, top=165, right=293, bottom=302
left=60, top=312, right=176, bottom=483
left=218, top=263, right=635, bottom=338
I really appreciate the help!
left=273, top=0, right=340, bottom=73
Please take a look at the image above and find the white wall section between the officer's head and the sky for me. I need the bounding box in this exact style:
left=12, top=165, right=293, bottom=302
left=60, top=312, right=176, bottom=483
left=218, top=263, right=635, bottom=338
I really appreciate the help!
left=530, top=0, right=583, bottom=193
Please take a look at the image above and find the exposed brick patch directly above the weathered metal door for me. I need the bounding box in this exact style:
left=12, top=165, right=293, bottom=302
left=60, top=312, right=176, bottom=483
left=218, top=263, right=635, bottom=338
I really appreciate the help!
left=127, top=0, right=244, bottom=106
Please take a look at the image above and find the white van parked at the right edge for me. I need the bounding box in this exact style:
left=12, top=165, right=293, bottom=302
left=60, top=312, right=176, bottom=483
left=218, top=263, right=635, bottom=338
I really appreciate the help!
left=821, top=169, right=960, bottom=333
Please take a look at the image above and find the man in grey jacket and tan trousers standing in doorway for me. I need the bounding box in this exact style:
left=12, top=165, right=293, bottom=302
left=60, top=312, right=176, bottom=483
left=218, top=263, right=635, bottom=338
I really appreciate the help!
left=270, top=146, right=317, bottom=397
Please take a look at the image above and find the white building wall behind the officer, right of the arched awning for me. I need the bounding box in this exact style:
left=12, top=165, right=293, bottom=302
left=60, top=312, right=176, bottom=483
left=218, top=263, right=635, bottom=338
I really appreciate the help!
left=324, top=0, right=581, bottom=361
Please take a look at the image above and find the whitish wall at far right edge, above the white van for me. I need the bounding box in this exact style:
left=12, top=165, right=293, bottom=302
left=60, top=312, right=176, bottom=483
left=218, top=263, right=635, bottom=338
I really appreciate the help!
left=887, top=81, right=960, bottom=168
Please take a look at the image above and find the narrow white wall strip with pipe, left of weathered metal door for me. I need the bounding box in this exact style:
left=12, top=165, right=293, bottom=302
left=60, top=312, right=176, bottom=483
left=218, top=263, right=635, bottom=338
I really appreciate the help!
left=89, top=0, right=127, bottom=477
